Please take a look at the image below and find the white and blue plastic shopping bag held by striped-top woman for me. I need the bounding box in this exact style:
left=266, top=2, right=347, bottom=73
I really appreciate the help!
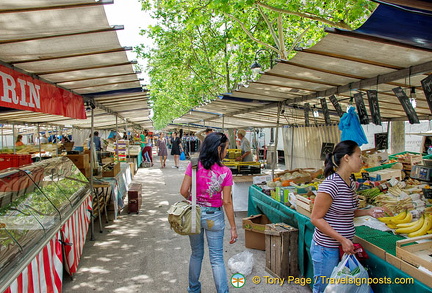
left=324, top=254, right=373, bottom=293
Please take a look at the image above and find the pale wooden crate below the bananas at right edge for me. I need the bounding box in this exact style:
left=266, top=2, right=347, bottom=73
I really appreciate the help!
left=396, top=234, right=432, bottom=271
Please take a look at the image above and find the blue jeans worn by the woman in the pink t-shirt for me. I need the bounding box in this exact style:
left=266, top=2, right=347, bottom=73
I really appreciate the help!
left=188, top=207, right=229, bottom=293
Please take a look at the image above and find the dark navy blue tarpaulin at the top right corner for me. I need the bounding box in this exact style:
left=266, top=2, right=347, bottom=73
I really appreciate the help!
left=355, top=5, right=432, bottom=49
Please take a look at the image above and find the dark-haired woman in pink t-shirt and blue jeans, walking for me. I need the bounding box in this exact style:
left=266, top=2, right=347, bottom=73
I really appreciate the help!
left=180, top=132, right=237, bottom=293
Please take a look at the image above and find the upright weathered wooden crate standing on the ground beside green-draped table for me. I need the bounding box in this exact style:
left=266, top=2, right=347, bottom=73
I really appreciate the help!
left=264, top=223, right=299, bottom=278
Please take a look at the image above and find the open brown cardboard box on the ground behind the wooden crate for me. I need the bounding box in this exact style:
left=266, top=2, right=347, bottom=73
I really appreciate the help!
left=243, top=214, right=271, bottom=250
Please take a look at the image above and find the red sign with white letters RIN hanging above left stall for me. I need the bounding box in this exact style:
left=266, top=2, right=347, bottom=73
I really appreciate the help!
left=0, top=65, right=87, bottom=119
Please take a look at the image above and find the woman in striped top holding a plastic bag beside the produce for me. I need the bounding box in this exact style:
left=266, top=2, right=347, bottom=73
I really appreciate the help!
left=310, top=140, right=384, bottom=293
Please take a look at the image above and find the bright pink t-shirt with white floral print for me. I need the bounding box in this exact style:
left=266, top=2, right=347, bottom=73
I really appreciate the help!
left=185, top=162, right=233, bottom=207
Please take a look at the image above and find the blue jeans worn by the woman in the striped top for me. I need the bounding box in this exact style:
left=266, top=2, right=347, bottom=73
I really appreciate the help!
left=310, top=240, right=339, bottom=293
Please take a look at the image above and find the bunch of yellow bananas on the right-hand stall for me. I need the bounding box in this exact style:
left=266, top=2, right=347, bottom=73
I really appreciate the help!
left=378, top=211, right=432, bottom=237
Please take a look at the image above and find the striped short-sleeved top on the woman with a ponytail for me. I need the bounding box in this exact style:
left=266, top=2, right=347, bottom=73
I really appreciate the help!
left=313, top=173, right=358, bottom=248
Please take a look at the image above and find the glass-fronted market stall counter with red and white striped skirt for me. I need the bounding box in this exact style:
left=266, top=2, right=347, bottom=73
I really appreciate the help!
left=0, top=157, right=91, bottom=291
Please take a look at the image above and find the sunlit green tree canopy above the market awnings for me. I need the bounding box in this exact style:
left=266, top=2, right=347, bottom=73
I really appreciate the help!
left=135, top=0, right=376, bottom=129
